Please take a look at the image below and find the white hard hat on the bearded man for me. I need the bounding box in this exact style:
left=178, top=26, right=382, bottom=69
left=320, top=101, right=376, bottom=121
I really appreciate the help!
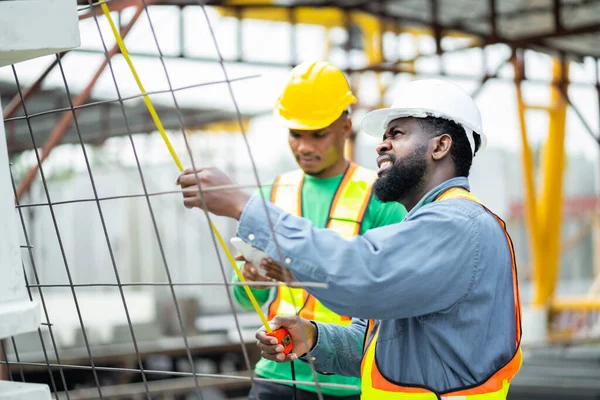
left=361, top=79, right=487, bottom=155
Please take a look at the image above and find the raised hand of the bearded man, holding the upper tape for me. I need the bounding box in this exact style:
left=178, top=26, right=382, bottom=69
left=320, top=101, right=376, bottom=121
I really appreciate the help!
left=177, top=168, right=250, bottom=220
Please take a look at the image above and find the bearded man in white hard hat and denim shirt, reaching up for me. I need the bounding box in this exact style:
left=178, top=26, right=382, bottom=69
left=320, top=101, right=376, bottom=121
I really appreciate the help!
left=180, top=80, right=522, bottom=400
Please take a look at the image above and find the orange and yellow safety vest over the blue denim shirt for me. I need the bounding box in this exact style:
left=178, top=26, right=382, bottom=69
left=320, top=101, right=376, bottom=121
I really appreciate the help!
left=361, top=188, right=523, bottom=400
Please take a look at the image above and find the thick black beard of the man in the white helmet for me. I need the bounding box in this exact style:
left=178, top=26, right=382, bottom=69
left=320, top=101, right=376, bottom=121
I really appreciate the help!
left=373, top=146, right=427, bottom=203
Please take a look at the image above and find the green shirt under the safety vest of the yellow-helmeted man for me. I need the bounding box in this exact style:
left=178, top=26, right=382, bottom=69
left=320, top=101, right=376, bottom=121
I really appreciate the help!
left=233, top=167, right=406, bottom=396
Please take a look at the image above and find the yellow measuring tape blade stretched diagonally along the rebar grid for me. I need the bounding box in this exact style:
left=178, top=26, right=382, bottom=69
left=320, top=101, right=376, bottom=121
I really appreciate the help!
left=100, top=2, right=273, bottom=332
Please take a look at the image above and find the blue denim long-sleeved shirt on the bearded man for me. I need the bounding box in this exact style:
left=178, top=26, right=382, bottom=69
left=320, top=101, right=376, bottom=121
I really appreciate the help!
left=238, top=178, right=516, bottom=392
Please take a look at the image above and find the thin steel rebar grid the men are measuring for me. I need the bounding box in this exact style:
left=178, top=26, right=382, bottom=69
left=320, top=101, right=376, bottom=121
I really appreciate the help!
left=3, top=2, right=332, bottom=399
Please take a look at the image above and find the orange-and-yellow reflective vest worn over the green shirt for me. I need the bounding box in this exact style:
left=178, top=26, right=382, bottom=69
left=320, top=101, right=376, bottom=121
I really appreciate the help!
left=269, top=163, right=377, bottom=325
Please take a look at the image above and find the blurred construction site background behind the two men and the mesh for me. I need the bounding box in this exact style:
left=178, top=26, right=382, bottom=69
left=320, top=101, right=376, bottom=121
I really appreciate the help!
left=0, top=0, right=600, bottom=399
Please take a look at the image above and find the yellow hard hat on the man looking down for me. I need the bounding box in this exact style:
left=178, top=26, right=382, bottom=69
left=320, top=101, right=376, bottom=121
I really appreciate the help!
left=275, top=61, right=356, bottom=130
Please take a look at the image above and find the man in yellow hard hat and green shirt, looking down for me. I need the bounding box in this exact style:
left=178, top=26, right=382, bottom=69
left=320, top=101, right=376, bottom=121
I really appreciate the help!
left=233, top=61, right=406, bottom=400
